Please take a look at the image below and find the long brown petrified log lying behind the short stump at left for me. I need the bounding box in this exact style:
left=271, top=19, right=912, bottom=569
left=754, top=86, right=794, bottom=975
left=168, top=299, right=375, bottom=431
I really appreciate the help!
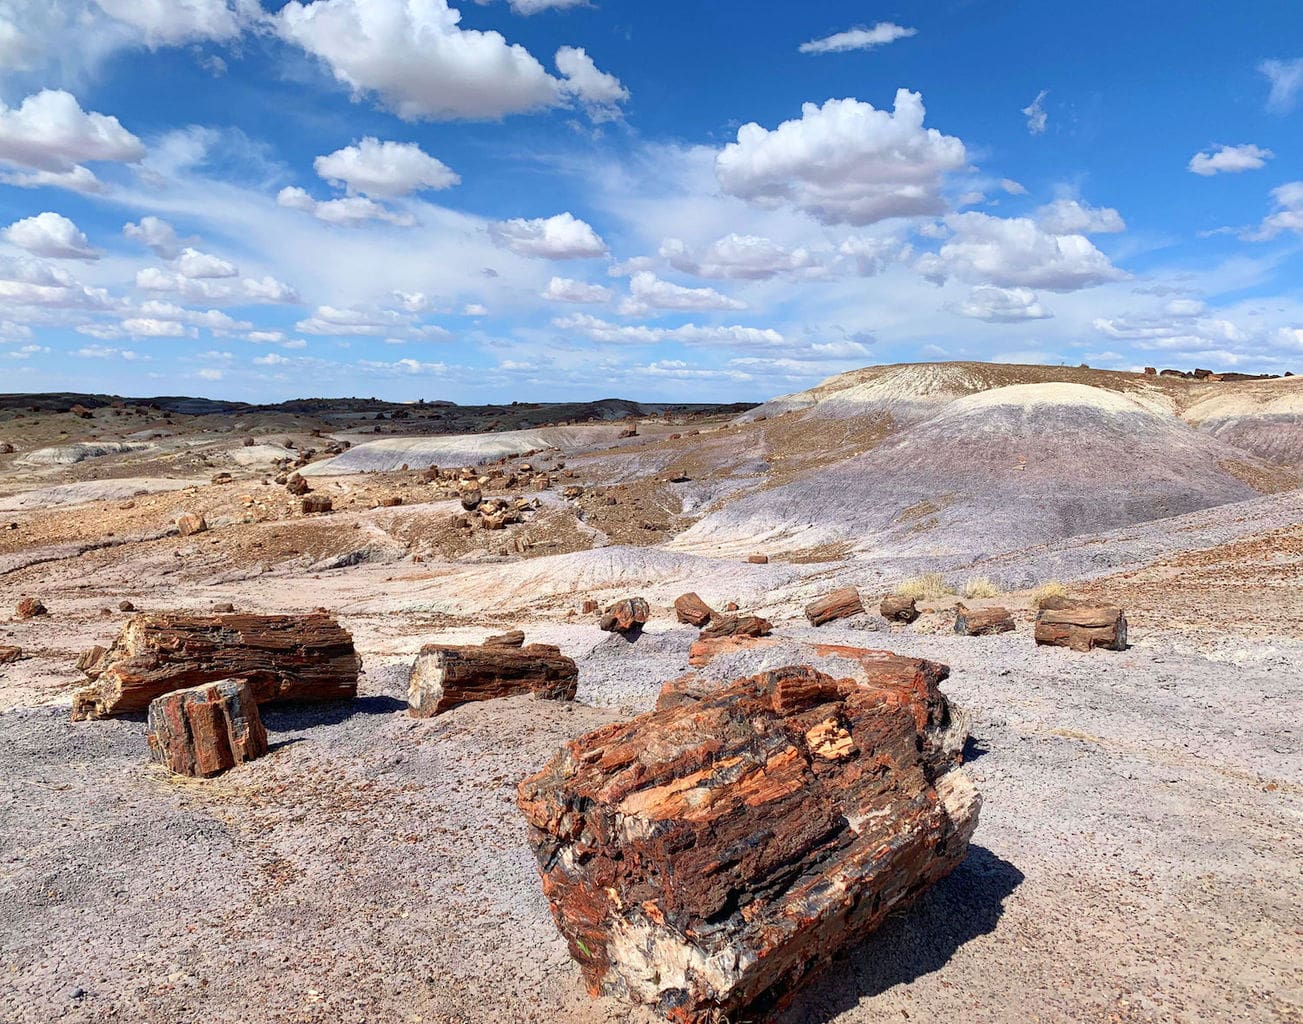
left=73, top=612, right=361, bottom=720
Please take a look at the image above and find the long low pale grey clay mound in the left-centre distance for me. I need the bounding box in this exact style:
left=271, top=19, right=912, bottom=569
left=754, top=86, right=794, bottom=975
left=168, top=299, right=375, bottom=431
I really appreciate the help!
left=300, top=425, right=635, bottom=477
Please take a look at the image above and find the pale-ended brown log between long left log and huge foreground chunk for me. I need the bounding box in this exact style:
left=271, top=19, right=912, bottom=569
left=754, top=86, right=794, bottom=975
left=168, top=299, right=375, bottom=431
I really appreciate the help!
left=408, top=644, right=579, bottom=718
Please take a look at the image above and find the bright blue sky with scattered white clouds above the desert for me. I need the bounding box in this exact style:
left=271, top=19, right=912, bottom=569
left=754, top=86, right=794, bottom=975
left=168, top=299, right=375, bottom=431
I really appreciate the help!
left=0, top=0, right=1303, bottom=401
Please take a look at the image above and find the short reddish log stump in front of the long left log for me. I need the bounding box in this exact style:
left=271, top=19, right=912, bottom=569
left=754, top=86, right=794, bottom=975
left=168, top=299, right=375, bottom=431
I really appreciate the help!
left=147, top=679, right=267, bottom=778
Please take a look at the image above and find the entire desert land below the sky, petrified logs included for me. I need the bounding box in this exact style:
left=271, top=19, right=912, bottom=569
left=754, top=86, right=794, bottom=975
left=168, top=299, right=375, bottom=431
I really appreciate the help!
left=0, top=362, right=1303, bottom=1024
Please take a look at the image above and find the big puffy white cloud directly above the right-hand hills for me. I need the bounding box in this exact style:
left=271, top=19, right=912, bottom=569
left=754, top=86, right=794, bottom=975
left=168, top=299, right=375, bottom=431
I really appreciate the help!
left=715, top=89, right=967, bottom=225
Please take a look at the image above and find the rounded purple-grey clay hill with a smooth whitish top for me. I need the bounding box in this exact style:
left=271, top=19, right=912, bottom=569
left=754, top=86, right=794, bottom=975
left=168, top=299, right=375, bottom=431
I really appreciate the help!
left=671, top=383, right=1267, bottom=556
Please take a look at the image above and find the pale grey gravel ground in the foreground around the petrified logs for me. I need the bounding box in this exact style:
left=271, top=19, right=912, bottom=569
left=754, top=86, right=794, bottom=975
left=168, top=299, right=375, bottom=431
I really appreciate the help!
left=0, top=609, right=1303, bottom=1024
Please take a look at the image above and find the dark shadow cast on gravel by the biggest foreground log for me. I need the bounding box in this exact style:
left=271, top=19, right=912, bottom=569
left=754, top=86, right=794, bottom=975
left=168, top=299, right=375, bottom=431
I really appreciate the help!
left=776, top=846, right=1024, bottom=1024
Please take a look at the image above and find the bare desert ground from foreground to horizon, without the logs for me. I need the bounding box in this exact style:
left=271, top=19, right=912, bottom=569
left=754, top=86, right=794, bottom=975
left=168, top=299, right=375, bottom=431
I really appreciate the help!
left=0, top=367, right=1303, bottom=1024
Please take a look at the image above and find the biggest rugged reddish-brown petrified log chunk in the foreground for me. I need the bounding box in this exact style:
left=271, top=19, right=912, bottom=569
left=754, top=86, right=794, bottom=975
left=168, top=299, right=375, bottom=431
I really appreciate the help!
left=517, top=666, right=980, bottom=1024
